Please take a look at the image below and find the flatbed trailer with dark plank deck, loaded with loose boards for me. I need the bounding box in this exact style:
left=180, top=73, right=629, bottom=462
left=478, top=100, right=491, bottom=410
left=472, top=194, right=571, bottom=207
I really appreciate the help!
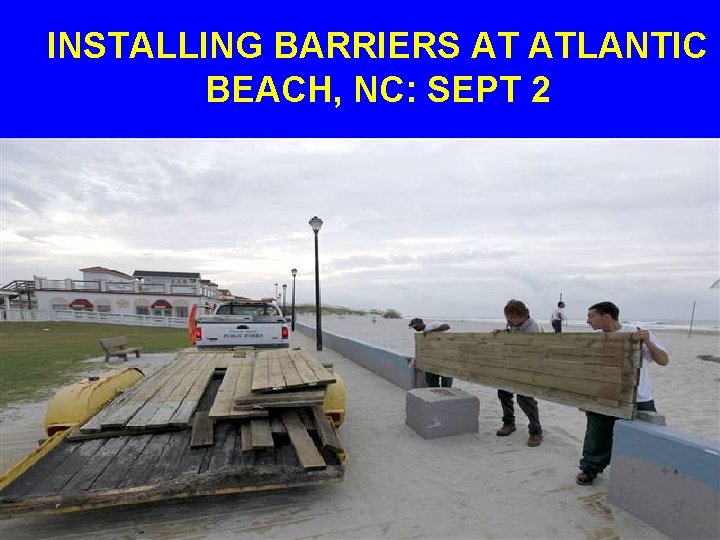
left=0, top=353, right=347, bottom=516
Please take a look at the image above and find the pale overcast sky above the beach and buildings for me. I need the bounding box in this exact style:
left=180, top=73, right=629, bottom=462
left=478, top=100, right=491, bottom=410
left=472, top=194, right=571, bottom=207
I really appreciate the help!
left=0, top=139, right=720, bottom=321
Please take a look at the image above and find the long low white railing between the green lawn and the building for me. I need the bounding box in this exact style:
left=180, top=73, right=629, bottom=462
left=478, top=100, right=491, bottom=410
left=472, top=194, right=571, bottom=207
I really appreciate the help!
left=0, top=309, right=187, bottom=328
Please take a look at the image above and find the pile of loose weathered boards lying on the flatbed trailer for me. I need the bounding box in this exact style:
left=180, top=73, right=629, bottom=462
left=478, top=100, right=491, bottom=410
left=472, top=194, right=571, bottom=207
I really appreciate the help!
left=69, top=349, right=343, bottom=470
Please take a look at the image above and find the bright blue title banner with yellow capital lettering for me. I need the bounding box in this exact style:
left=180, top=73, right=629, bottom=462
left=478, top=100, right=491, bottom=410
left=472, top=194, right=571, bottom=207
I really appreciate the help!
left=0, top=1, right=720, bottom=137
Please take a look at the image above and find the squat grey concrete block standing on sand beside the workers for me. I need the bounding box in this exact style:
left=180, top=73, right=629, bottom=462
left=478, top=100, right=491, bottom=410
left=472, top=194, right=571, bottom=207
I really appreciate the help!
left=405, top=388, right=480, bottom=439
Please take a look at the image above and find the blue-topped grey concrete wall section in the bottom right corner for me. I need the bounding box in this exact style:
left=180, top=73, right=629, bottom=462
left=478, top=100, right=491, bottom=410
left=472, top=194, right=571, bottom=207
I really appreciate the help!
left=607, top=420, right=720, bottom=539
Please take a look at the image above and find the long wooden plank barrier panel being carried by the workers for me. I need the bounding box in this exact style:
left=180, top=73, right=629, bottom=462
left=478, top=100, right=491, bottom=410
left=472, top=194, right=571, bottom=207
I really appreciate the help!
left=415, top=332, right=641, bottom=419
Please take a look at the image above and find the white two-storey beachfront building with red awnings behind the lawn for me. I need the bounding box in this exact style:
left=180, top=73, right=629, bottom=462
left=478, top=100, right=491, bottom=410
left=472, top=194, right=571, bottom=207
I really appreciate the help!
left=28, top=266, right=218, bottom=318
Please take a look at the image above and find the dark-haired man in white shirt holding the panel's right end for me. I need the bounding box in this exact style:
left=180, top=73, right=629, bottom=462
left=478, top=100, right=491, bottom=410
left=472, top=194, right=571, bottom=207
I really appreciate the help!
left=575, top=302, right=670, bottom=486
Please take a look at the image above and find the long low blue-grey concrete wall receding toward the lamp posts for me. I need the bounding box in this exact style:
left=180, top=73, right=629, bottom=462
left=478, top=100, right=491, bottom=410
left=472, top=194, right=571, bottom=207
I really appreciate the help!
left=295, top=322, right=425, bottom=390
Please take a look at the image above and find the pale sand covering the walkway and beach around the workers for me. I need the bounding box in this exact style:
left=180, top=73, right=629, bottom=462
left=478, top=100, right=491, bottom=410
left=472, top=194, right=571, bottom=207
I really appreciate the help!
left=0, top=326, right=720, bottom=540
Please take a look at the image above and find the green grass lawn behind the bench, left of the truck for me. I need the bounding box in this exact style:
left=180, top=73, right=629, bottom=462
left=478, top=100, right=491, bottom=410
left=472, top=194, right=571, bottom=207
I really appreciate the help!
left=0, top=321, right=189, bottom=408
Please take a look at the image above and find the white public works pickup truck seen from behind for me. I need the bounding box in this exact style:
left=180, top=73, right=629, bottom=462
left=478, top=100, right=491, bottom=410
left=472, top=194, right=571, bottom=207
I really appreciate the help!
left=194, top=300, right=290, bottom=349
